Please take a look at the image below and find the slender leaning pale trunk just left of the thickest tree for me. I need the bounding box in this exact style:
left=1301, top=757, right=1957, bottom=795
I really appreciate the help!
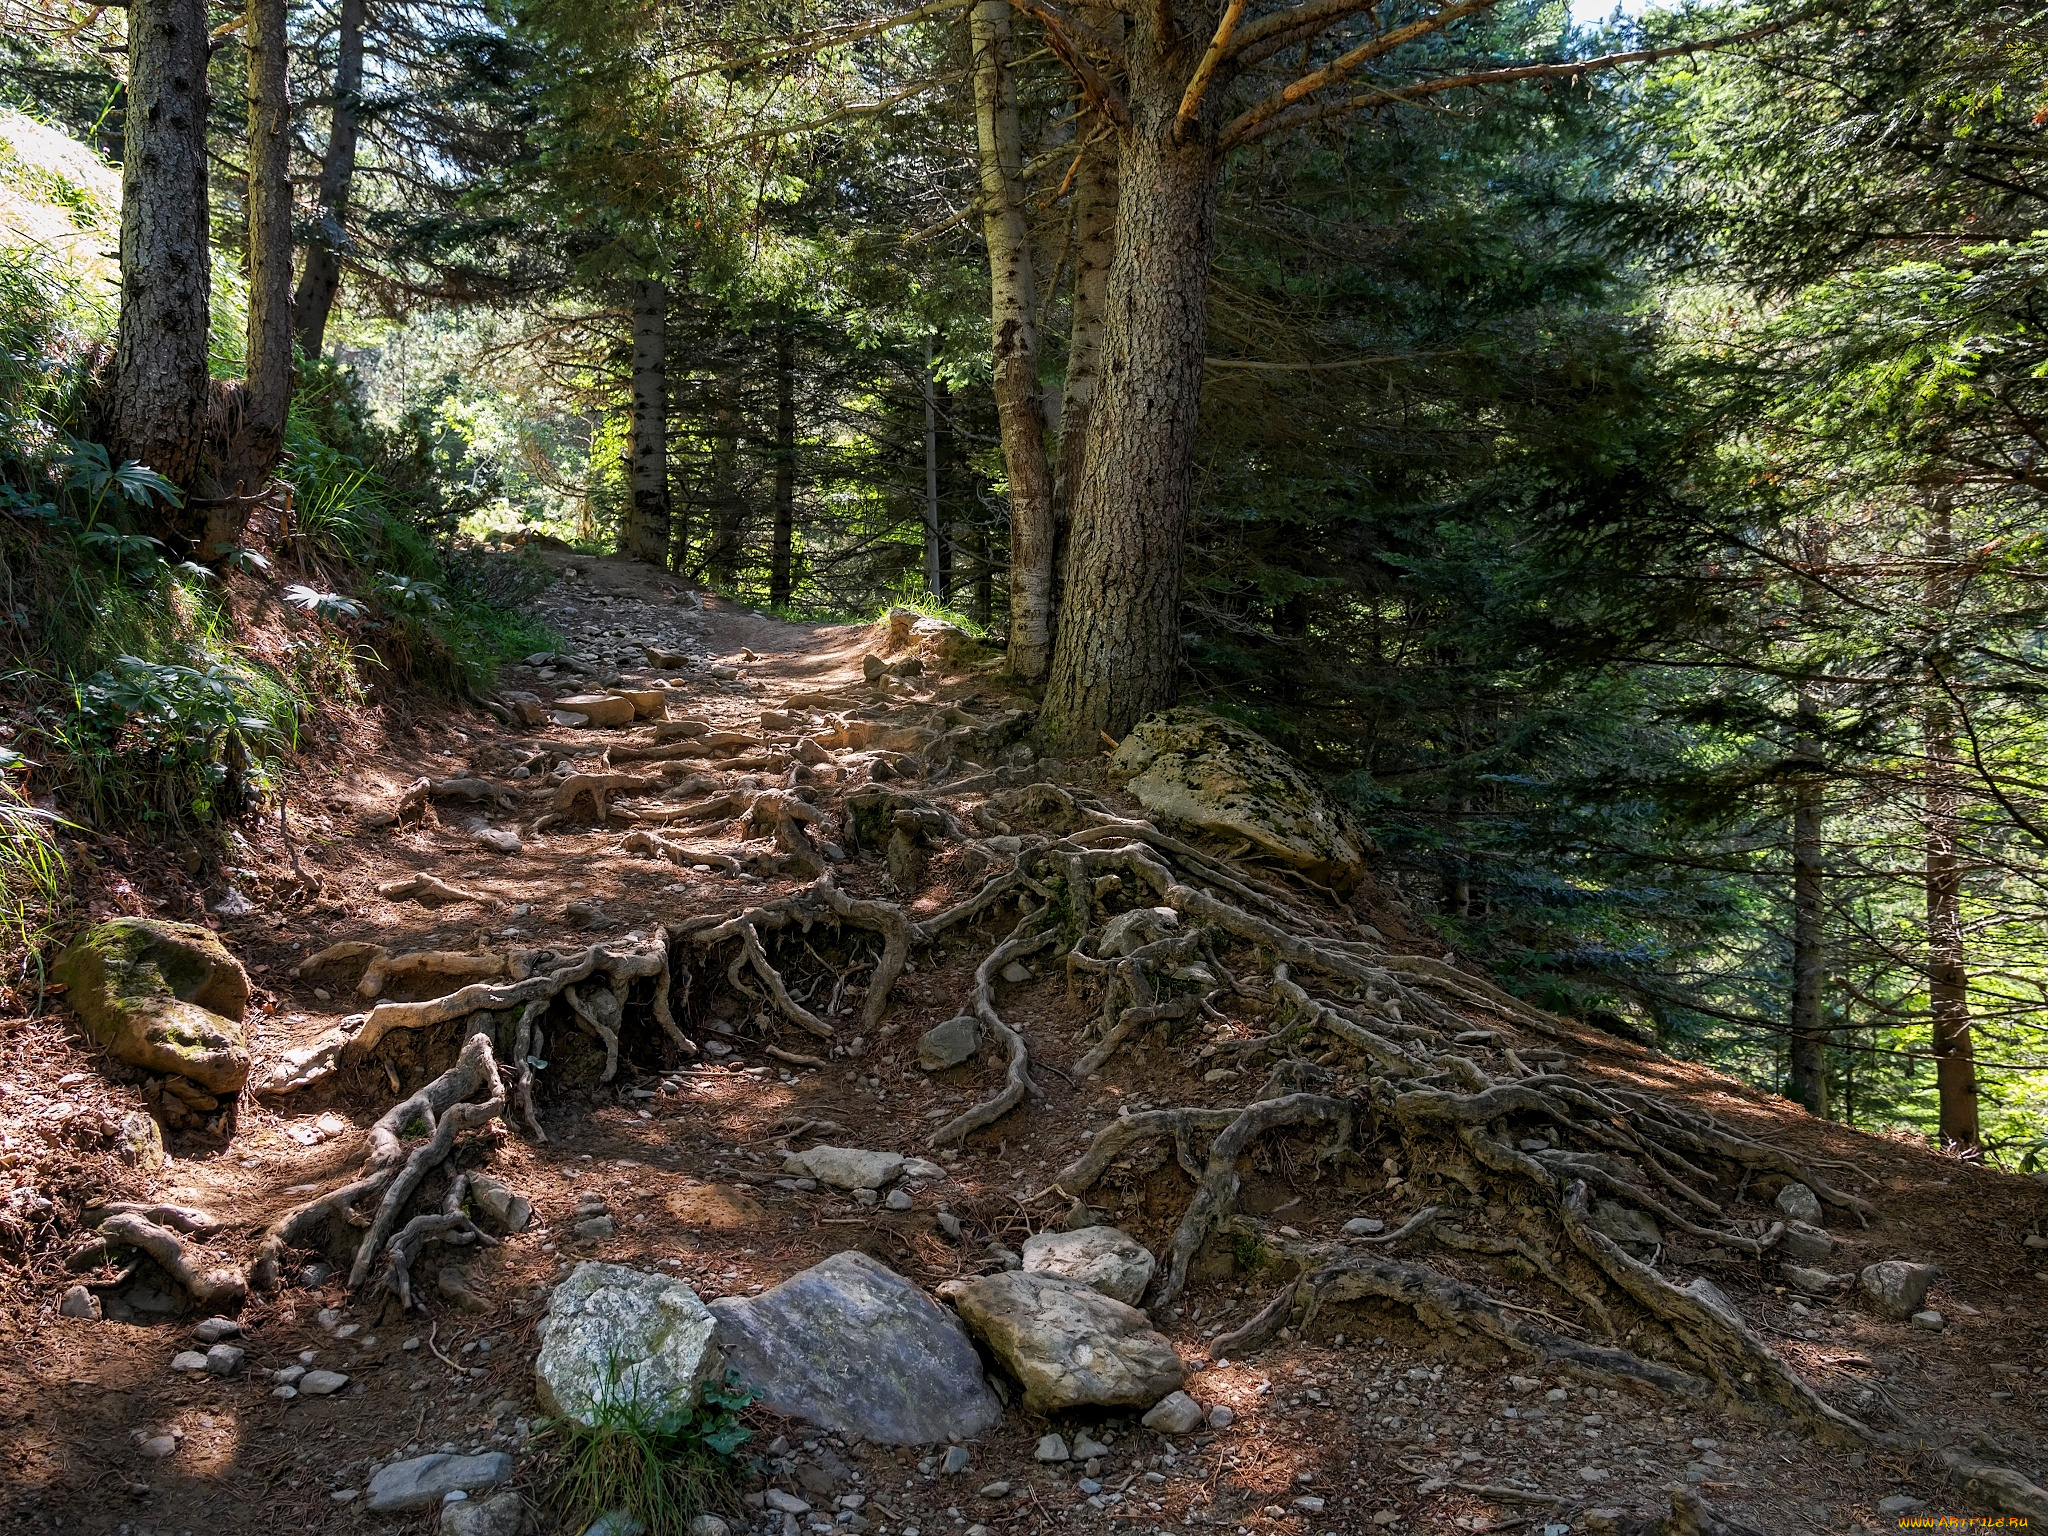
left=971, top=0, right=1055, bottom=680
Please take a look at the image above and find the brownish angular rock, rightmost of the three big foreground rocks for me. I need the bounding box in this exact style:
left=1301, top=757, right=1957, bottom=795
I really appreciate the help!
left=946, top=1270, right=1186, bottom=1413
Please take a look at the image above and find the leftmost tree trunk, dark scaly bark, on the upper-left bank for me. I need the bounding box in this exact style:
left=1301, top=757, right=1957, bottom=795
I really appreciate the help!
left=111, top=0, right=213, bottom=489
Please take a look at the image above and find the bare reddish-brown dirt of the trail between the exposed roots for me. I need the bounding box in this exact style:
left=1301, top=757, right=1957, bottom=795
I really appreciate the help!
left=0, top=555, right=2048, bottom=1536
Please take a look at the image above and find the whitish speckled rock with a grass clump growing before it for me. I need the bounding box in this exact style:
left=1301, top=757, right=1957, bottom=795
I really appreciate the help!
left=532, top=1264, right=723, bottom=1423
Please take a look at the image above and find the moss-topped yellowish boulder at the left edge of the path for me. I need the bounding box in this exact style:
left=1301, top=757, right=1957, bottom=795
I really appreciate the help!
left=51, top=918, right=250, bottom=1094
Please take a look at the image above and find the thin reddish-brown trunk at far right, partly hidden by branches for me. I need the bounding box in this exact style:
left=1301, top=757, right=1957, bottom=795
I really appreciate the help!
left=1923, top=496, right=1980, bottom=1155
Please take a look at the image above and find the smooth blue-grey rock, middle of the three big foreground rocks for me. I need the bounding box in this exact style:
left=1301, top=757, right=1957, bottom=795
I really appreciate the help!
left=711, top=1253, right=1004, bottom=1446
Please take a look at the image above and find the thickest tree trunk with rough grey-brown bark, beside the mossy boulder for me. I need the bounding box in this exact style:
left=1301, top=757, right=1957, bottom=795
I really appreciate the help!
left=1040, top=24, right=1225, bottom=752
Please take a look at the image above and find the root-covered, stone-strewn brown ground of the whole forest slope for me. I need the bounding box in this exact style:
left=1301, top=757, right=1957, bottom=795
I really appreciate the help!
left=0, top=553, right=2048, bottom=1536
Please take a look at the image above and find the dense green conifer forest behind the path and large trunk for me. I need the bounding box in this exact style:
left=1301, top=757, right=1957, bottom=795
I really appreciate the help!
left=0, top=0, right=2048, bottom=1167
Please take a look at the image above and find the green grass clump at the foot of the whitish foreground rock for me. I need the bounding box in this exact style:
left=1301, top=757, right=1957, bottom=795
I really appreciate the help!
left=547, top=1370, right=754, bottom=1536
